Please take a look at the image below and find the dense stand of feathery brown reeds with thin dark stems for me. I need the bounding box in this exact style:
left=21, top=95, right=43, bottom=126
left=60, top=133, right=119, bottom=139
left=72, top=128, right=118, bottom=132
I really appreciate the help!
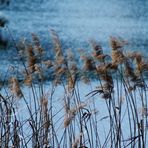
left=0, top=30, right=148, bottom=148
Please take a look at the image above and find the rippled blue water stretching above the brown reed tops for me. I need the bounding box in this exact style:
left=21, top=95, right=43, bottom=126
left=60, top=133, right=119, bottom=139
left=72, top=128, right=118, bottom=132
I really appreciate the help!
left=0, top=0, right=148, bottom=71
